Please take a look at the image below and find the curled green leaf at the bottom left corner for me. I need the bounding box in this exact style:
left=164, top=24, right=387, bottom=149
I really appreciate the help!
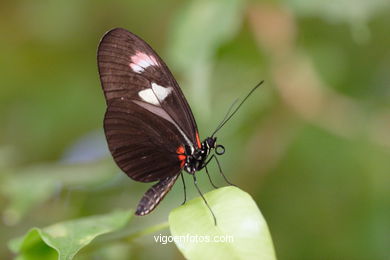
left=9, top=210, right=133, bottom=260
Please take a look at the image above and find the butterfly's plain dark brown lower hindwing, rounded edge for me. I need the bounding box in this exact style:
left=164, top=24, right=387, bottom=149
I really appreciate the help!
left=104, top=99, right=183, bottom=182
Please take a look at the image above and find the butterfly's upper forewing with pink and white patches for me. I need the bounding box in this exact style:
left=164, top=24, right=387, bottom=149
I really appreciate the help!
left=98, top=28, right=197, bottom=147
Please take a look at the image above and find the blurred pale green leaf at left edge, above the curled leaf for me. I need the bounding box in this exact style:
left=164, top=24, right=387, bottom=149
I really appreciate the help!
left=1, top=160, right=114, bottom=225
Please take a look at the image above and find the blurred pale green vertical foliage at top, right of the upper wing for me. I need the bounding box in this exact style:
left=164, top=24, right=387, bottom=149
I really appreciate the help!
left=168, top=0, right=243, bottom=117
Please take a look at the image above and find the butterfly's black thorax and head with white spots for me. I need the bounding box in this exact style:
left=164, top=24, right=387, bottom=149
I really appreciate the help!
left=184, top=137, right=217, bottom=174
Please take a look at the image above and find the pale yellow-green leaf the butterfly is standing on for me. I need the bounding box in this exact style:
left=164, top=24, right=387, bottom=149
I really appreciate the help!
left=169, top=186, right=276, bottom=260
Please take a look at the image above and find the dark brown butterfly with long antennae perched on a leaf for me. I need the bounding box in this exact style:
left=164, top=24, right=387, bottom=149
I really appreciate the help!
left=98, top=28, right=262, bottom=221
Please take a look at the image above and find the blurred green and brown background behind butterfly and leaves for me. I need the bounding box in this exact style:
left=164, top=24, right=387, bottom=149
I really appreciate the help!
left=0, top=0, right=390, bottom=259
